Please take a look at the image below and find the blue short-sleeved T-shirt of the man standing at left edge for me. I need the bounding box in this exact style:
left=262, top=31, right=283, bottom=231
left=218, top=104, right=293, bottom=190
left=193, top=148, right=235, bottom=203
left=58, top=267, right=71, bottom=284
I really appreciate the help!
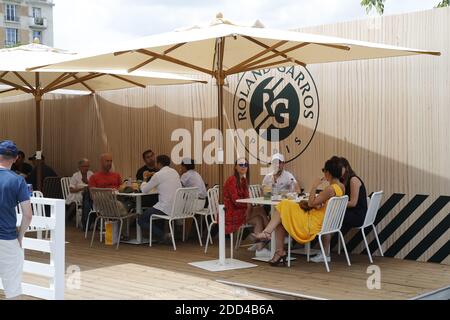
left=0, top=168, right=30, bottom=240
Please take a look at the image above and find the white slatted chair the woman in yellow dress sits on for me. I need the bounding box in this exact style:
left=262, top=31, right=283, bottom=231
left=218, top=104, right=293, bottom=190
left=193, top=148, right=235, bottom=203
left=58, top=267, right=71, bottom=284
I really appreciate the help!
left=288, top=196, right=351, bottom=272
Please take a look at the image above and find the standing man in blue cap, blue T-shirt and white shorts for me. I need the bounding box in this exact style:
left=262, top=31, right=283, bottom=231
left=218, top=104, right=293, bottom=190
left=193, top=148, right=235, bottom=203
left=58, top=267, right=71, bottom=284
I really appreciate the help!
left=0, top=140, right=32, bottom=299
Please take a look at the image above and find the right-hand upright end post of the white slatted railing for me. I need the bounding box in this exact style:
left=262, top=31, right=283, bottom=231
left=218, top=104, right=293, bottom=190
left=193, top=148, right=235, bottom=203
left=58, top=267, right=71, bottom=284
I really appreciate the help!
left=50, top=200, right=66, bottom=300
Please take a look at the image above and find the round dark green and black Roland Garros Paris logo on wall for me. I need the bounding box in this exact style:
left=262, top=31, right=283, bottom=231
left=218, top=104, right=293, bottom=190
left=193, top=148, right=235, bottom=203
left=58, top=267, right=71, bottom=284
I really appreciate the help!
left=233, top=66, right=319, bottom=162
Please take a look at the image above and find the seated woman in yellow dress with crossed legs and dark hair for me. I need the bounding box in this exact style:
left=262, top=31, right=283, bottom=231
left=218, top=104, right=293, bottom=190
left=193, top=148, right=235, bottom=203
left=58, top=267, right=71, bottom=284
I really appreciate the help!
left=253, top=158, right=345, bottom=266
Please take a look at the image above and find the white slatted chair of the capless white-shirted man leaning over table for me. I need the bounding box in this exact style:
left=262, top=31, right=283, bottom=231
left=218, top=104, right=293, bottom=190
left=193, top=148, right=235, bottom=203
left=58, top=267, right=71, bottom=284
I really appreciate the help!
left=149, top=188, right=202, bottom=250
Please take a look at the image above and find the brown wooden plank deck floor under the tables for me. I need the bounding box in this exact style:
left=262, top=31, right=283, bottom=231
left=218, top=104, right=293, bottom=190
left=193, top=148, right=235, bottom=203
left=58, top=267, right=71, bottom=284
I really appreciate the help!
left=3, top=228, right=450, bottom=300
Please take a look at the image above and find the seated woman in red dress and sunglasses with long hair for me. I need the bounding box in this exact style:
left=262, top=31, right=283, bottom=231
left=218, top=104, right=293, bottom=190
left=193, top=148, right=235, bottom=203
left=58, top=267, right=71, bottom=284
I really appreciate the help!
left=223, top=158, right=268, bottom=256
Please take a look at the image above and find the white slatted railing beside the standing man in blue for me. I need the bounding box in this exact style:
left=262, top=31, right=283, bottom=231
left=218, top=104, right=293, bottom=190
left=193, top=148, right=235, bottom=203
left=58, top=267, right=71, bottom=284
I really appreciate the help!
left=0, top=197, right=65, bottom=300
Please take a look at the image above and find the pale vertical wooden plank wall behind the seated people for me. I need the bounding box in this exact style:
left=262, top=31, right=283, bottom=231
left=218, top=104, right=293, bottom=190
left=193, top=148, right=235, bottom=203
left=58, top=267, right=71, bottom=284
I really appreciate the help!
left=0, top=8, right=450, bottom=264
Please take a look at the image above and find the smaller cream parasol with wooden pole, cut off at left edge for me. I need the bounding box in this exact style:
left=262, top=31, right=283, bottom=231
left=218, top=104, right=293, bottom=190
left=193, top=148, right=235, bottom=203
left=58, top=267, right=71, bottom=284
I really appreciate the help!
left=0, top=43, right=205, bottom=190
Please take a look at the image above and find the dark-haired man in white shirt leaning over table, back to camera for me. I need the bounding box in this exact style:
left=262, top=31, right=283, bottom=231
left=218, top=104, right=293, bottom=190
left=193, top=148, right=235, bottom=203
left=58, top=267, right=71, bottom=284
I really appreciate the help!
left=138, top=155, right=182, bottom=237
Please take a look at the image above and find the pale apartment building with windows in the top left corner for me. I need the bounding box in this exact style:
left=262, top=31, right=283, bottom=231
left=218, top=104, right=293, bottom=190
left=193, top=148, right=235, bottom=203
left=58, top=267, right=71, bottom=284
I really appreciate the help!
left=0, top=0, right=54, bottom=48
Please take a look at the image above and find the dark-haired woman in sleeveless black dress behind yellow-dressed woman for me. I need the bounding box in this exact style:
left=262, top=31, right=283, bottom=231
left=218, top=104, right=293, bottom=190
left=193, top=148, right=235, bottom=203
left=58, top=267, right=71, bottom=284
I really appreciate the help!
left=341, top=158, right=367, bottom=229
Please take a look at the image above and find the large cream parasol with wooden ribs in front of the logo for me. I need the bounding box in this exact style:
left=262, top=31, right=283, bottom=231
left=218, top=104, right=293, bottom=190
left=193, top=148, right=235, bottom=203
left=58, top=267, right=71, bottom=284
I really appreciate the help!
left=33, top=13, right=440, bottom=190
